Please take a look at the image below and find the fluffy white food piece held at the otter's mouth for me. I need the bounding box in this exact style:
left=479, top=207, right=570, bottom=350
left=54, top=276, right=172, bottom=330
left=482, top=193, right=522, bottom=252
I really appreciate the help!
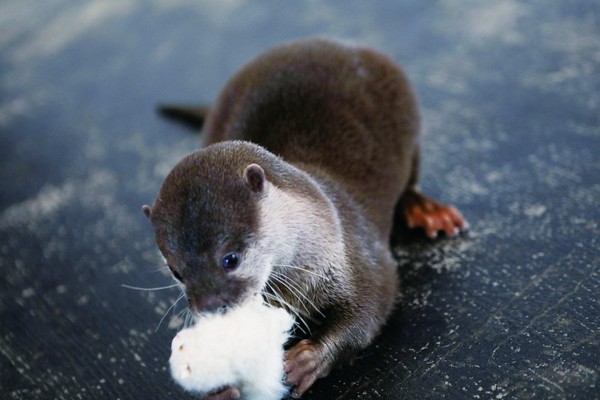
left=169, top=297, right=294, bottom=400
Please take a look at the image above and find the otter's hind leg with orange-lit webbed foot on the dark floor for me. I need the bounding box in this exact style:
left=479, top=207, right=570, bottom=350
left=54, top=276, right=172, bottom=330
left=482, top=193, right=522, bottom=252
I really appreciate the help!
left=396, top=149, right=468, bottom=239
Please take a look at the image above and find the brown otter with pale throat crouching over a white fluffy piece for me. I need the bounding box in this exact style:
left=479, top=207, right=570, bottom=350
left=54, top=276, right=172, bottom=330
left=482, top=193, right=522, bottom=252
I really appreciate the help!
left=143, top=39, right=466, bottom=400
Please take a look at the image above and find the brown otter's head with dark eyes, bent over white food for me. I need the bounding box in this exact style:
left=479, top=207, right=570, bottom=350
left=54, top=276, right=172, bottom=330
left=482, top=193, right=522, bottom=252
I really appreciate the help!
left=143, top=145, right=270, bottom=313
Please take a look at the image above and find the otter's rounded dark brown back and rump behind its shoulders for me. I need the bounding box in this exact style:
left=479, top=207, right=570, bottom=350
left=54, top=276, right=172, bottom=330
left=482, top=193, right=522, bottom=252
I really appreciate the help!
left=205, top=39, right=419, bottom=231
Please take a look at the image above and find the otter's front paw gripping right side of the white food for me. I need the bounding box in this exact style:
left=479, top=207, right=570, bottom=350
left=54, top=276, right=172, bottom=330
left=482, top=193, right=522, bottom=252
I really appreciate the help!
left=284, top=339, right=331, bottom=399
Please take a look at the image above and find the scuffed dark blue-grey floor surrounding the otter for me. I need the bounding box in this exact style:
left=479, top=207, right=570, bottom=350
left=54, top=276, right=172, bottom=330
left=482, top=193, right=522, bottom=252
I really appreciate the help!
left=0, top=0, right=600, bottom=400
